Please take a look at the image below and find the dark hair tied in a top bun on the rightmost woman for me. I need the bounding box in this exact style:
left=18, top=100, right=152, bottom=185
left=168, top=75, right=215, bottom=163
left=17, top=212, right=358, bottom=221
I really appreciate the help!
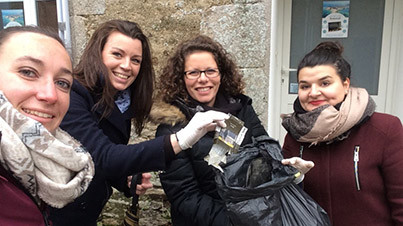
left=297, top=42, right=351, bottom=82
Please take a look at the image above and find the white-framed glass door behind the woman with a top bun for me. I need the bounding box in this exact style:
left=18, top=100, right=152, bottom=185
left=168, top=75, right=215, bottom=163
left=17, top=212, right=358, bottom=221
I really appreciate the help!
left=269, top=0, right=399, bottom=143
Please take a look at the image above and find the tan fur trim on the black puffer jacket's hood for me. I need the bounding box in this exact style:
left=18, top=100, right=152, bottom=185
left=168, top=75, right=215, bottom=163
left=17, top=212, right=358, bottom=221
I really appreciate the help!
left=149, top=100, right=187, bottom=126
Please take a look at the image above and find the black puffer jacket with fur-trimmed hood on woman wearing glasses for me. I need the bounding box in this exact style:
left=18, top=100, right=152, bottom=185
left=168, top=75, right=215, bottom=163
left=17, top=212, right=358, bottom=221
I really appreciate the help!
left=152, top=95, right=267, bottom=226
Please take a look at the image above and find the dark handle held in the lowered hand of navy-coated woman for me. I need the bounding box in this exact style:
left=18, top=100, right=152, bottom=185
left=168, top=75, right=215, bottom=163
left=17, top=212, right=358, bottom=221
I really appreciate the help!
left=123, top=173, right=142, bottom=226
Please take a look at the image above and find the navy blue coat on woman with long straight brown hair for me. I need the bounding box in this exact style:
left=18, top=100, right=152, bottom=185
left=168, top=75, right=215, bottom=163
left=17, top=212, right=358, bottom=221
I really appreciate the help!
left=50, top=80, right=165, bottom=226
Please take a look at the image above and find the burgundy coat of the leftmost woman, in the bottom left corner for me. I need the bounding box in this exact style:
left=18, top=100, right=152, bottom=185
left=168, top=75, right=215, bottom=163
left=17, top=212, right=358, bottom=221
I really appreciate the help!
left=0, top=165, right=49, bottom=226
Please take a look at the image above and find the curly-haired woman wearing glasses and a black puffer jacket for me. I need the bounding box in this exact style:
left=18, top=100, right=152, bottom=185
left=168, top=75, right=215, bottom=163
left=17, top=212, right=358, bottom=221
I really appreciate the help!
left=151, top=36, right=267, bottom=225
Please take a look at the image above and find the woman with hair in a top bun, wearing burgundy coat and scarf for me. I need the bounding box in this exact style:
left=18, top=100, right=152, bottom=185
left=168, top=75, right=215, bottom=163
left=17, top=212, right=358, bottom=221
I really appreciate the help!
left=282, top=42, right=403, bottom=226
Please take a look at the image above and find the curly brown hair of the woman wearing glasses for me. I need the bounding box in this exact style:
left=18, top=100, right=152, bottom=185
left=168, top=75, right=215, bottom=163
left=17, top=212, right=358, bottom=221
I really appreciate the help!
left=158, top=35, right=245, bottom=103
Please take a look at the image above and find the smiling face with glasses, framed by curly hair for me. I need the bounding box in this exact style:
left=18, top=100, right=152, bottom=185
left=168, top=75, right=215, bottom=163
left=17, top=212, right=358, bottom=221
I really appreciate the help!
left=184, top=51, right=221, bottom=107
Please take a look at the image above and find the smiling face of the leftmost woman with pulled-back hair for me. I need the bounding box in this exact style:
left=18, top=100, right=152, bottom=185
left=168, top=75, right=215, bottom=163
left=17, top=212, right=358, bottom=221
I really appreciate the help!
left=0, top=32, right=73, bottom=132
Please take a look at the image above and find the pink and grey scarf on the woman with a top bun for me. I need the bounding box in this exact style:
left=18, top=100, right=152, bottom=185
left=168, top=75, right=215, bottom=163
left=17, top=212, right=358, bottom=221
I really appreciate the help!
left=281, top=87, right=375, bottom=145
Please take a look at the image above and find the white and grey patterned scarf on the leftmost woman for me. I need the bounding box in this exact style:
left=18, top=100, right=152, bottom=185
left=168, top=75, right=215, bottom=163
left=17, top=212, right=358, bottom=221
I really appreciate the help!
left=0, top=91, right=95, bottom=208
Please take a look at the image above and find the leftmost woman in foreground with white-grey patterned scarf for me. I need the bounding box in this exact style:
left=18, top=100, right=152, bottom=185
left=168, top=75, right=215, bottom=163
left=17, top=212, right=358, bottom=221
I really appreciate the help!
left=0, top=26, right=94, bottom=226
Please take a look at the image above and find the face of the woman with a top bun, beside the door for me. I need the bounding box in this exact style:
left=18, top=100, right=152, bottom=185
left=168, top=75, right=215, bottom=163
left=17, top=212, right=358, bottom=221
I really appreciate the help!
left=298, top=65, right=350, bottom=111
